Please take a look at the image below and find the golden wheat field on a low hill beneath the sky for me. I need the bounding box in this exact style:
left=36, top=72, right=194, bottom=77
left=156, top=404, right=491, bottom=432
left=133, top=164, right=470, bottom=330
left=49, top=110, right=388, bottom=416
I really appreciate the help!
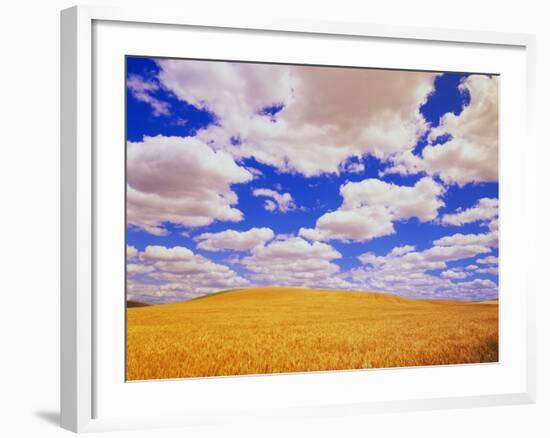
left=127, top=288, right=498, bottom=380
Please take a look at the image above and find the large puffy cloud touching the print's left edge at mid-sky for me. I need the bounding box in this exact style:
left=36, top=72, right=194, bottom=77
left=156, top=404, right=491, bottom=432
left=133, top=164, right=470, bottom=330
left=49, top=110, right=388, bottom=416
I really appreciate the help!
left=127, top=135, right=253, bottom=235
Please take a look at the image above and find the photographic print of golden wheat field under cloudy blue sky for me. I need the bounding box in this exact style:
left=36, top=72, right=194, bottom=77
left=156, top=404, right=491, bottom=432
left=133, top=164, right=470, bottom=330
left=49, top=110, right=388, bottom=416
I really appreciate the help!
left=124, top=56, right=499, bottom=381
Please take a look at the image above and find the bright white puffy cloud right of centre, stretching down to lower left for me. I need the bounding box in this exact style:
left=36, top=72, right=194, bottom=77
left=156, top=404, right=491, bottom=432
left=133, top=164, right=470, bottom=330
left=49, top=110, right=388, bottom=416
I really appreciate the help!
left=299, top=177, right=444, bottom=241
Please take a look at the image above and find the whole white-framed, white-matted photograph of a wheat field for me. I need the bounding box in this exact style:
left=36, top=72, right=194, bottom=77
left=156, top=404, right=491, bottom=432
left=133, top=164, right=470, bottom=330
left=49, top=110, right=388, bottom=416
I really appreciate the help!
left=61, top=7, right=535, bottom=431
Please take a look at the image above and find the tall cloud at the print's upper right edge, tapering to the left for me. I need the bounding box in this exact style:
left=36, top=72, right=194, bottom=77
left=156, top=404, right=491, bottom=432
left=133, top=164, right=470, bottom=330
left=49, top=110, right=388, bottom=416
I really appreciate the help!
left=383, top=75, right=499, bottom=187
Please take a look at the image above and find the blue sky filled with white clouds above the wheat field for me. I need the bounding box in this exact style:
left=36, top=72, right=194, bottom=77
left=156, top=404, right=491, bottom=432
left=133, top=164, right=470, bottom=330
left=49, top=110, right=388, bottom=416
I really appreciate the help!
left=126, top=57, right=498, bottom=302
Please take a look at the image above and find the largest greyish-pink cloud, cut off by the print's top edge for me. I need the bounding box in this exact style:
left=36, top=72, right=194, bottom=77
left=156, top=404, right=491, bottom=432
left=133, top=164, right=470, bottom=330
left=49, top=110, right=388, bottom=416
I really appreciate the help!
left=152, top=60, right=436, bottom=176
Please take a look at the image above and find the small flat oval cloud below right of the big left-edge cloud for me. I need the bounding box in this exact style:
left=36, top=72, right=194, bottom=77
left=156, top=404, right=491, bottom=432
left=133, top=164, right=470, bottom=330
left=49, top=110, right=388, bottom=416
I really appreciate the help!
left=195, top=228, right=275, bottom=251
